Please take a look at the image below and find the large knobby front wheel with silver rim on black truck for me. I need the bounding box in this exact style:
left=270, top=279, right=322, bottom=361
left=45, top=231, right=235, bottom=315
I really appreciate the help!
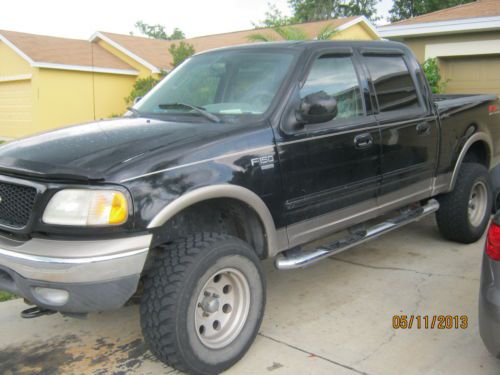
left=140, top=233, right=265, bottom=374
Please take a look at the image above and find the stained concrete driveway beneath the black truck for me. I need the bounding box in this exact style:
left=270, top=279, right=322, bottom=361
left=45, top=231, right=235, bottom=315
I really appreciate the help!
left=0, top=218, right=500, bottom=375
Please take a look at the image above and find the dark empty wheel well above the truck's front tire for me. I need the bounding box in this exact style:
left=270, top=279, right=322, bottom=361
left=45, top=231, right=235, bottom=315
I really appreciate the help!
left=153, top=198, right=268, bottom=259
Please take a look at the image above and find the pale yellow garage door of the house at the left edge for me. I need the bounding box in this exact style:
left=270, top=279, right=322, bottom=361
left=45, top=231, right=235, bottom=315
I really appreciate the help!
left=0, top=80, right=32, bottom=138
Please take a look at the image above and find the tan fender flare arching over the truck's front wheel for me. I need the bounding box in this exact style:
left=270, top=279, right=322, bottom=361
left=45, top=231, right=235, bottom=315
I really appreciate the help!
left=148, top=184, right=288, bottom=255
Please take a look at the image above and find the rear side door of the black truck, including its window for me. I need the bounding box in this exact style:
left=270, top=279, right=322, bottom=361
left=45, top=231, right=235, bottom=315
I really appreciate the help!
left=363, top=50, right=439, bottom=205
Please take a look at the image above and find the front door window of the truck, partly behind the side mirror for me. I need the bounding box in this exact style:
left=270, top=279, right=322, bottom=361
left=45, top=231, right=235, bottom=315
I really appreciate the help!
left=300, top=55, right=364, bottom=119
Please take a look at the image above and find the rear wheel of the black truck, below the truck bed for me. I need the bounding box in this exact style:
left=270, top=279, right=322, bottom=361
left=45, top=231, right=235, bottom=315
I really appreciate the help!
left=436, top=163, right=493, bottom=244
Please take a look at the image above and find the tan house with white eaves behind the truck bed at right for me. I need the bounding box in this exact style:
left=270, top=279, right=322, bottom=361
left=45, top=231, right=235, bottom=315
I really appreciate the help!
left=379, top=0, right=500, bottom=95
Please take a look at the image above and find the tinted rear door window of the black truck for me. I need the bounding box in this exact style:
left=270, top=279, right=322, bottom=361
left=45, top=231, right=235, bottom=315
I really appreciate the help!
left=365, top=56, right=420, bottom=112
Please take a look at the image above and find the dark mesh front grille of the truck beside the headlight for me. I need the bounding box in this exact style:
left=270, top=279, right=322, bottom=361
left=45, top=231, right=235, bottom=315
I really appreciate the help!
left=0, top=182, right=37, bottom=228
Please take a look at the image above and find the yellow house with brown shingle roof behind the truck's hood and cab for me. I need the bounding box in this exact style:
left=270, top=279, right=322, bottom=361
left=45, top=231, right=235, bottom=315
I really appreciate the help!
left=0, top=17, right=380, bottom=139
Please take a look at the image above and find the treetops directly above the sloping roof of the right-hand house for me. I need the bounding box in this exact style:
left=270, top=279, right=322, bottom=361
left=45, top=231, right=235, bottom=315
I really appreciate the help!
left=388, top=0, right=474, bottom=22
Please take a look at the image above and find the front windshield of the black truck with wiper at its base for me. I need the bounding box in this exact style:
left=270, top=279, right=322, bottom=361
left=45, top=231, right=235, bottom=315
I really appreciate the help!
left=134, top=50, right=294, bottom=119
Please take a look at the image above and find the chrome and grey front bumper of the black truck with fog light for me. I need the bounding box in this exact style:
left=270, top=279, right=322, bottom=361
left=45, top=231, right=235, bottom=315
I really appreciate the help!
left=0, top=234, right=152, bottom=313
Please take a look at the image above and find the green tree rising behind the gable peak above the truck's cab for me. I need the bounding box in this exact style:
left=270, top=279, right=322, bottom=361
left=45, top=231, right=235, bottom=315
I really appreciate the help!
left=288, top=0, right=380, bottom=23
